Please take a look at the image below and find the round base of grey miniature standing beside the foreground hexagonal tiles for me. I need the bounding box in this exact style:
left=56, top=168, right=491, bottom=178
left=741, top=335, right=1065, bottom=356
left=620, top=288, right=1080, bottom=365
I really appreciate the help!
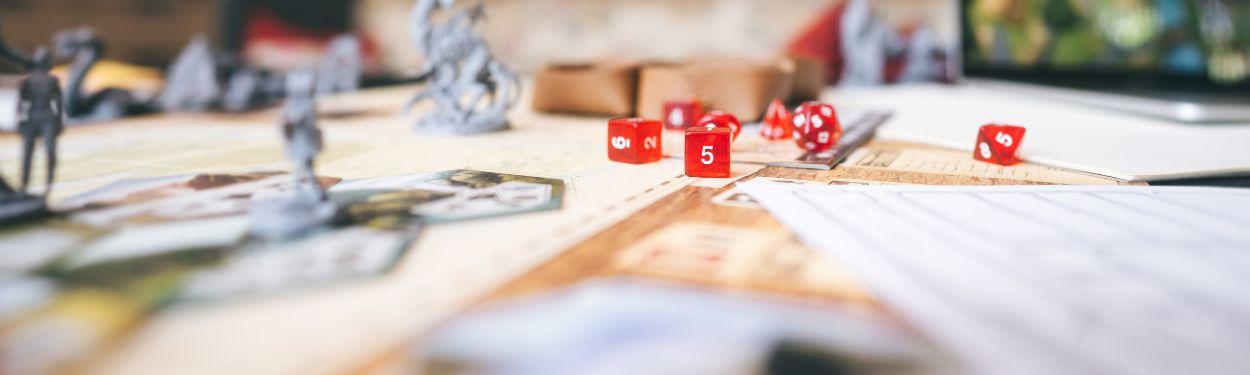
left=248, top=198, right=338, bottom=240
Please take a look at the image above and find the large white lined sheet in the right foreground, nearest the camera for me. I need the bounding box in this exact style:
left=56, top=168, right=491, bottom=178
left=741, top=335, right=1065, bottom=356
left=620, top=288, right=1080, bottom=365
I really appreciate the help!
left=741, top=183, right=1250, bottom=374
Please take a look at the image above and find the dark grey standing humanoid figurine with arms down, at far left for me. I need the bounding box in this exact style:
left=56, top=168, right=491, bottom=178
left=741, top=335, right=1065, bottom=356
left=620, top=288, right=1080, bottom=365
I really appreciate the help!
left=18, top=48, right=64, bottom=199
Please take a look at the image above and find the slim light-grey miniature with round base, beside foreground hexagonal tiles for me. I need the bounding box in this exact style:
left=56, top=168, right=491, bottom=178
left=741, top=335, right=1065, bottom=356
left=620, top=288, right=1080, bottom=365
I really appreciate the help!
left=249, top=70, right=336, bottom=240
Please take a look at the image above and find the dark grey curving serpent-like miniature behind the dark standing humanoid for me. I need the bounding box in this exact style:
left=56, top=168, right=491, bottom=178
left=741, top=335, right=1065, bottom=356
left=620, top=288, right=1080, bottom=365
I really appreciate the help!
left=53, top=28, right=146, bottom=121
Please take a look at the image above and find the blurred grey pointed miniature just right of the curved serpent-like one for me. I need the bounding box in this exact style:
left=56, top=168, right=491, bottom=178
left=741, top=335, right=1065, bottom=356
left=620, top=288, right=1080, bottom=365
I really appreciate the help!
left=156, top=35, right=221, bottom=111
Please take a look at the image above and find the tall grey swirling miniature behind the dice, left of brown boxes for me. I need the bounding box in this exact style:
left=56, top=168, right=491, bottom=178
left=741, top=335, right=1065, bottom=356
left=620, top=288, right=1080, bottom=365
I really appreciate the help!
left=404, top=0, right=520, bottom=135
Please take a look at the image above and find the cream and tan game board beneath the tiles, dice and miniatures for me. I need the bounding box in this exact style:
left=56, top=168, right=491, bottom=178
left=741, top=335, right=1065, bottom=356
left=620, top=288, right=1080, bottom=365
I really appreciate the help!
left=0, top=86, right=1135, bottom=374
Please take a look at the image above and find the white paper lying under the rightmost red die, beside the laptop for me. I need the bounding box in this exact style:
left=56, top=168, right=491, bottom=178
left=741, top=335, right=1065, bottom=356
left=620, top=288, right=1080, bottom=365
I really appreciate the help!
left=825, top=85, right=1250, bottom=181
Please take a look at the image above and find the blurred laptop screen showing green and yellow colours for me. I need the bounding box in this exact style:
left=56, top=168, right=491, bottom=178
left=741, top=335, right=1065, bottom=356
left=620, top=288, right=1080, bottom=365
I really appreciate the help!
left=960, top=0, right=1250, bottom=89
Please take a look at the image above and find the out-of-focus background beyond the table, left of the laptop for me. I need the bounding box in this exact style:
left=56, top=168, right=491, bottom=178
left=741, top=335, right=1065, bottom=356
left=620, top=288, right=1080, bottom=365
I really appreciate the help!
left=0, top=0, right=958, bottom=76
